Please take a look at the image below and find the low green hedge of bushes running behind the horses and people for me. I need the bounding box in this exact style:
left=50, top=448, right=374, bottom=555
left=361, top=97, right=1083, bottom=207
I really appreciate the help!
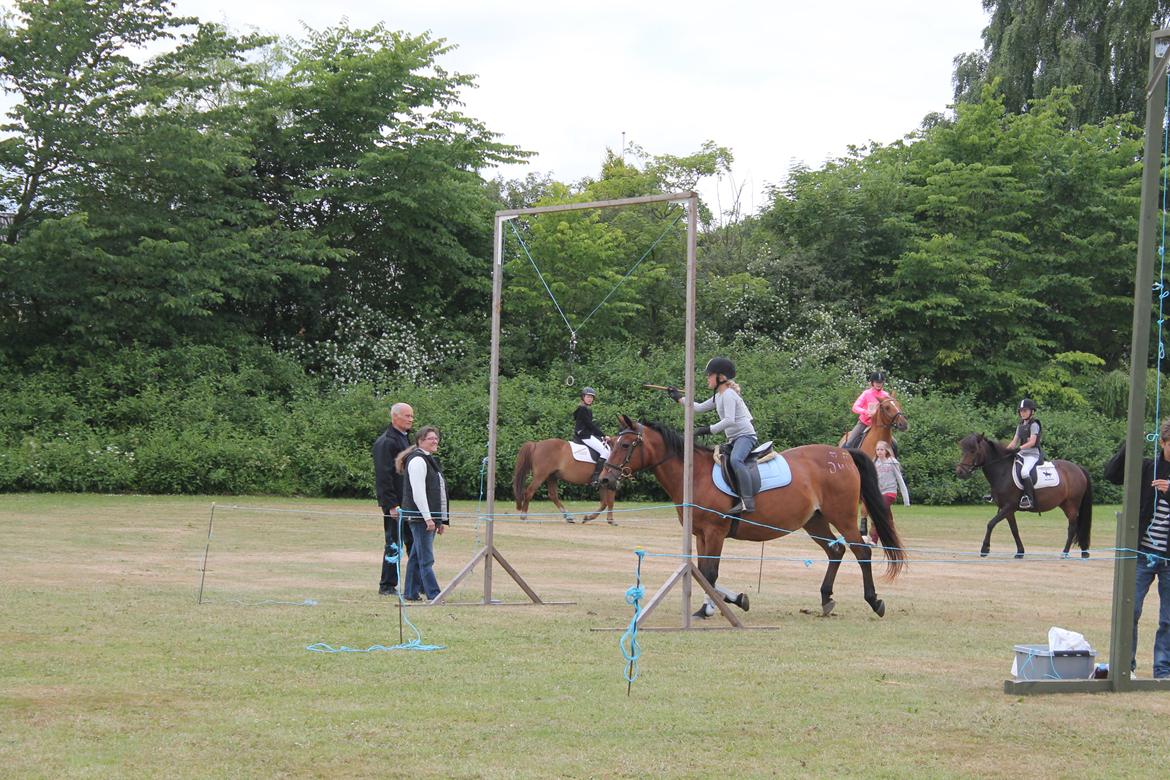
left=0, top=344, right=1151, bottom=504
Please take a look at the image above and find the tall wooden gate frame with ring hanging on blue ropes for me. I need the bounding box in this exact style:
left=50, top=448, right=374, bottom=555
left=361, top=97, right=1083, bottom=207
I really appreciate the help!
left=431, top=192, right=743, bottom=628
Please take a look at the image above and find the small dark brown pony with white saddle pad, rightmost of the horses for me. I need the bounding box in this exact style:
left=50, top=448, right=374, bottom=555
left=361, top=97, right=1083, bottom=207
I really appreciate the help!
left=955, top=434, right=1093, bottom=558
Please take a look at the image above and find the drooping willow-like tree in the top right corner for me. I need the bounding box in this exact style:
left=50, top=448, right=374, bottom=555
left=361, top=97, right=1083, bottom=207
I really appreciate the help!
left=955, top=0, right=1170, bottom=125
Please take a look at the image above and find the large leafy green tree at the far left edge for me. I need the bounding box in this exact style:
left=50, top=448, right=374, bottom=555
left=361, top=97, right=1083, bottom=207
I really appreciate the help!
left=0, top=0, right=336, bottom=356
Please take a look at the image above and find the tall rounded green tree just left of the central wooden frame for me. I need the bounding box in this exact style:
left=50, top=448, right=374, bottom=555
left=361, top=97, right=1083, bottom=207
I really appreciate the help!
left=243, top=23, right=528, bottom=379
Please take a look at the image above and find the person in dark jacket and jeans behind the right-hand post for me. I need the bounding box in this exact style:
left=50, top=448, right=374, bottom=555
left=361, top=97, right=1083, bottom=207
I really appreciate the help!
left=1104, top=420, right=1170, bottom=677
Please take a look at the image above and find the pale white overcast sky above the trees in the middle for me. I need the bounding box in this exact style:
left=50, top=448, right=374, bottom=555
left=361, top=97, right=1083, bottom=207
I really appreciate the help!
left=34, top=0, right=986, bottom=213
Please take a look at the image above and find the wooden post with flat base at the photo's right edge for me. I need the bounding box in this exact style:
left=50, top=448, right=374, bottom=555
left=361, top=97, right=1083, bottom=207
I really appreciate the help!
left=1004, top=29, right=1170, bottom=693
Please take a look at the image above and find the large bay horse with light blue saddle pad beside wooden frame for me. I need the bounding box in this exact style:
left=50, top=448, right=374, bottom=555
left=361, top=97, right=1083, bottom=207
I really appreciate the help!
left=601, top=415, right=906, bottom=617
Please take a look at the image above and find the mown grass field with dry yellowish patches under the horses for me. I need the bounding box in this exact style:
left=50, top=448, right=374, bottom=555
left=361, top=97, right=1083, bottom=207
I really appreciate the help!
left=0, top=496, right=1170, bottom=778
